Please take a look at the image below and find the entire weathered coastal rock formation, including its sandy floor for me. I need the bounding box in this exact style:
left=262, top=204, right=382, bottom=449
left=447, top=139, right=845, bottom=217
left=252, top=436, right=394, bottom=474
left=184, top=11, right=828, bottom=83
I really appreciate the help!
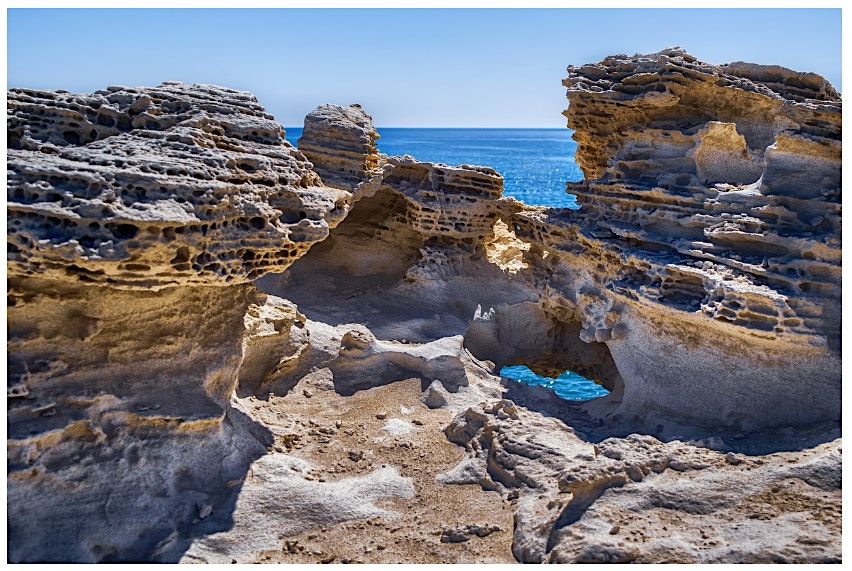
left=7, top=49, right=841, bottom=562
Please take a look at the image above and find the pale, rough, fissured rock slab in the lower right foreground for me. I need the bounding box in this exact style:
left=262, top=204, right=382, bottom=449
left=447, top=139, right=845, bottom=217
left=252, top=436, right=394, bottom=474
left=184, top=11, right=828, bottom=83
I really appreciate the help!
left=440, top=400, right=841, bottom=563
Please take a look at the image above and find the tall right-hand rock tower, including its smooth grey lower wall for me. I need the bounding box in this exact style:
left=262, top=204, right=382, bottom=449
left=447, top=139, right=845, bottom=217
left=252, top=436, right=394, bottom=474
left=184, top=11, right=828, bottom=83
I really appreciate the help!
left=564, top=49, right=841, bottom=427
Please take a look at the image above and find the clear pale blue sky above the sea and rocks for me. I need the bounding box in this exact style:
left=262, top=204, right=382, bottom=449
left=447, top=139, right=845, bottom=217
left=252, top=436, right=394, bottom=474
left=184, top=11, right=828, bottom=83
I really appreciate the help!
left=8, top=9, right=841, bottom=127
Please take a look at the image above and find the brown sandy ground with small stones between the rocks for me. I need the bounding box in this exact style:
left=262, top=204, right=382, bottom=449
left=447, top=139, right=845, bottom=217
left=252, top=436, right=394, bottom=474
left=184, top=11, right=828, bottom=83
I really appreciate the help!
left=236, top=379, right=515, bottom=563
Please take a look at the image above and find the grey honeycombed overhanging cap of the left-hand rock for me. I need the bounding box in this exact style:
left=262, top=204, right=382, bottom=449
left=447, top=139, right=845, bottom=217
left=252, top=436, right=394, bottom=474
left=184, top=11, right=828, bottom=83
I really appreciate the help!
left=7, top=83, right=348, bottom=289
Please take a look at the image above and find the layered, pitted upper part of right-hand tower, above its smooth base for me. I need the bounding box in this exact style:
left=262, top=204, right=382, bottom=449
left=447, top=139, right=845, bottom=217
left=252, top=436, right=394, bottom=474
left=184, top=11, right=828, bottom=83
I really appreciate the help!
left=564, top=48, right=841, bottom=350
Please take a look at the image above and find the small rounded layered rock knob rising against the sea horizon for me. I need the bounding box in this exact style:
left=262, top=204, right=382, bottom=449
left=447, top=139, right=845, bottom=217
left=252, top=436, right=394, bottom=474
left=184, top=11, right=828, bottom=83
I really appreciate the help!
left=298, top=104, right=380, bottom=190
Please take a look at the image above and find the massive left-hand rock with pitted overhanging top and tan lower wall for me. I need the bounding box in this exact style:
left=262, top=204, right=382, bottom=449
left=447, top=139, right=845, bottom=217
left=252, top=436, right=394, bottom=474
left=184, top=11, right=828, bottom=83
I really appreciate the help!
left=7, top=83, right=349, bottom=561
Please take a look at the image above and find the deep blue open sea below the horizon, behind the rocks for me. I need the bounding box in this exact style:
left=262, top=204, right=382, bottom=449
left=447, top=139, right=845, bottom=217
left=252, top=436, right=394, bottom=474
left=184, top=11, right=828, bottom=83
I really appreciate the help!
left=286, top=127, right=583, bottom=208
